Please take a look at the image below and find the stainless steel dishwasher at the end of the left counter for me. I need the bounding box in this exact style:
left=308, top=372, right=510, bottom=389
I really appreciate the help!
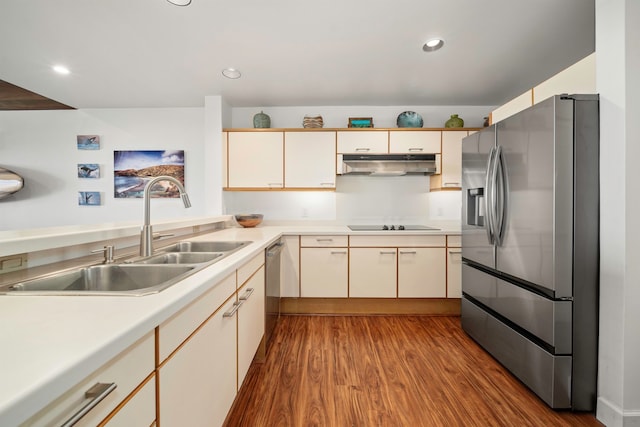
left=264, top=239, right=284, bottom=349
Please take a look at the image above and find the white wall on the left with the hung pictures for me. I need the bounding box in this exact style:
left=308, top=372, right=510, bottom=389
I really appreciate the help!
left=0, top=108, right=222, bottom=230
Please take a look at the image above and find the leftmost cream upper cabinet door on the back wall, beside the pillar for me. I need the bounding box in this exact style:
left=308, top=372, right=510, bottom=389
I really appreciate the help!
left=227, top=132, right=284, bottom=188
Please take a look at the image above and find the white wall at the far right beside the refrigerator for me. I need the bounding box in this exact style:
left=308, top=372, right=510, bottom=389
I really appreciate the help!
left=596, top=0, right=640, bottom=427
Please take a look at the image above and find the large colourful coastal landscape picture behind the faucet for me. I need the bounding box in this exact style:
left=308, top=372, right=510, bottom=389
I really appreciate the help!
left=113, top=150, right=184, bottom=198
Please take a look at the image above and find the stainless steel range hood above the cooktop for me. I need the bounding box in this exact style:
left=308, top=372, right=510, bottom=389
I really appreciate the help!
left=338, top=154, right=438, bottom=176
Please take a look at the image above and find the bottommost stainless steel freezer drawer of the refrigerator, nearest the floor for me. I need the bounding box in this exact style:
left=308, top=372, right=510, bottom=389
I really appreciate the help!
left=461, top=296, right=571, bottom=409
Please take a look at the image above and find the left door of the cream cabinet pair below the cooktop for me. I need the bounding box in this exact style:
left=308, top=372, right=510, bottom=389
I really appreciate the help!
left=349, top=248, right=397, bottom=298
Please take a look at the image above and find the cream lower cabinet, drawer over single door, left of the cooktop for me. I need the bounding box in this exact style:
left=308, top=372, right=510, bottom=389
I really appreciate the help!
left=300, top=235, right=349, bottom=298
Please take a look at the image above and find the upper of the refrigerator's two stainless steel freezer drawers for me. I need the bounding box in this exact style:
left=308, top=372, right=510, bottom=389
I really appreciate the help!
left=462, top=264, right=572, bottom=354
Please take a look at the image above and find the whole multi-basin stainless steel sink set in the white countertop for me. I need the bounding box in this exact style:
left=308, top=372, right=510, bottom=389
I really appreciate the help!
left=0, top=241, right=251, bottom=296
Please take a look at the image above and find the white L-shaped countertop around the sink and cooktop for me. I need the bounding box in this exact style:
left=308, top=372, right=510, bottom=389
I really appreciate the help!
left=0, top=224, right=460, bottom=426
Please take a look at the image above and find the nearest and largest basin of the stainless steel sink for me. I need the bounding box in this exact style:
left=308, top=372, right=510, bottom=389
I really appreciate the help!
left=1, top=264, right=196, bottom=296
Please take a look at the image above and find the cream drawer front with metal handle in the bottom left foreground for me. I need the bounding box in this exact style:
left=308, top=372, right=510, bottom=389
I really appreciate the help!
left=25, top=331, right=155, bottom=426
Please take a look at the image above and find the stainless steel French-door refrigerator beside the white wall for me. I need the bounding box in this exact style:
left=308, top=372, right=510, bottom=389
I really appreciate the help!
left=461, top=95, right=599, bottom=411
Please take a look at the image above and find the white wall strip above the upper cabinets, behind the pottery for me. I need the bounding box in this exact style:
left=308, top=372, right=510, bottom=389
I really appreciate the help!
left=232, top=105, right=495, bottom=128
